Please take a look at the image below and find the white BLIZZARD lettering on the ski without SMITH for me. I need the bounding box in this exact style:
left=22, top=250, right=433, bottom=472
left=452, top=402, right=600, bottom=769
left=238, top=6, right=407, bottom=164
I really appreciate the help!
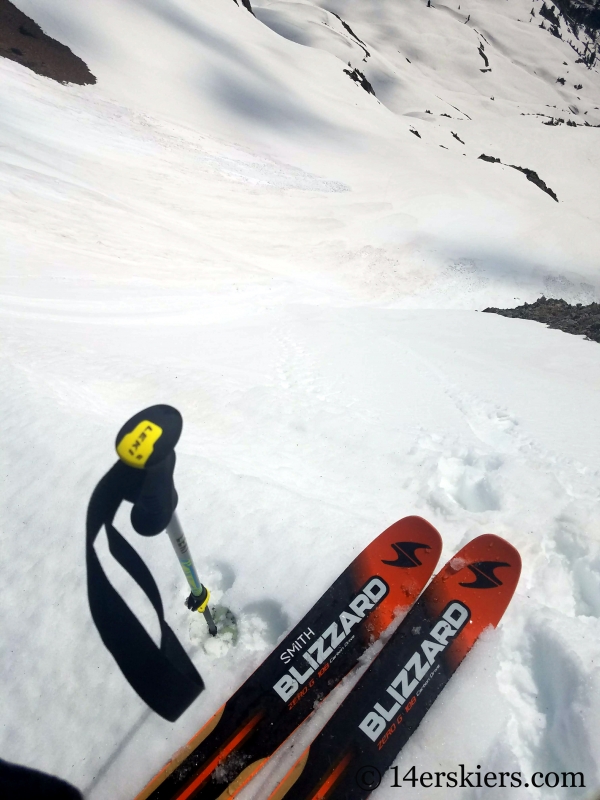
left=358, top=601, right=471, bottom=742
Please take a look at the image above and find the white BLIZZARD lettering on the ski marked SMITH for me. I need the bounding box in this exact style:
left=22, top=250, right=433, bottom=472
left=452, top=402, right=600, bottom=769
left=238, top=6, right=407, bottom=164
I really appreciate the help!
left=273, top=578, right=390, bottom=703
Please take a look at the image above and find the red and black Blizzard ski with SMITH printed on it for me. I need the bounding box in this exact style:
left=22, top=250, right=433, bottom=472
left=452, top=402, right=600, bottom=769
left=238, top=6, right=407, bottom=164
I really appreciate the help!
left=136, top=517, right=442, bottom=800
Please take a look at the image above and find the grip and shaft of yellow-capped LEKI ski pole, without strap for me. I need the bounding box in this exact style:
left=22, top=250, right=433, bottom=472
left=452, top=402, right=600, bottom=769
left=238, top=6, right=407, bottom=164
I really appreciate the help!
left=116, top=405, right=217, bottom=636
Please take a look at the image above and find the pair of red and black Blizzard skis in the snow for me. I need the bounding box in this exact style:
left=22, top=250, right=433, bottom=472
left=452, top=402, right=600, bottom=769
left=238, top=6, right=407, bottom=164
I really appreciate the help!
left=136, top=517, right=521, bottom=800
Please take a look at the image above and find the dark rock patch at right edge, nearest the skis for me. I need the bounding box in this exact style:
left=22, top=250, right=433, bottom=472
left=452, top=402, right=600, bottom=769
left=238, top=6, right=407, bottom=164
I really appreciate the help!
left=483, top=297, right=600, bottom=342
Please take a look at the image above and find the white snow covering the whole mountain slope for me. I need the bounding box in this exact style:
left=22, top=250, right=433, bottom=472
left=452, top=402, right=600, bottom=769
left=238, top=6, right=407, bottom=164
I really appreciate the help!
left=0, top=0, right=600, bottom=800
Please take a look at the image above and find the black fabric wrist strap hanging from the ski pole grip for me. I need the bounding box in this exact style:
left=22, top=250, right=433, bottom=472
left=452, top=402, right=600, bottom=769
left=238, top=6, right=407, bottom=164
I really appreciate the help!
left=86, top=461, right=204, bottom=722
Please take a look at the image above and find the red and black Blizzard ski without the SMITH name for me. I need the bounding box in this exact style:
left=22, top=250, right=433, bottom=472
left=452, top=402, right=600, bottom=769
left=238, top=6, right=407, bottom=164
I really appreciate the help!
left=269, top=534, right=521, bottom=800
